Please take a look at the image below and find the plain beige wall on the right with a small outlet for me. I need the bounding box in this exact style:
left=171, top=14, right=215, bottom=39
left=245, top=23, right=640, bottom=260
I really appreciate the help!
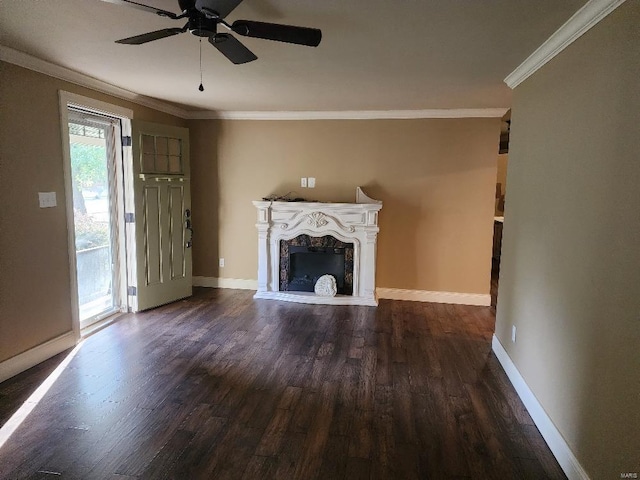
left=496, top=0, right=640, bottom=480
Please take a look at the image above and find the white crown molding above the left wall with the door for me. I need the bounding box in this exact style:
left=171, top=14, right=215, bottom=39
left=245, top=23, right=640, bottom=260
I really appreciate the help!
left=0, top=45, right=187, bottom=118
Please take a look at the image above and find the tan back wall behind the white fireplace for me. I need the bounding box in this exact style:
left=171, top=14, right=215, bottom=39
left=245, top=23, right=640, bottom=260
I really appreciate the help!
left=189, top=118, right=500, bottom=294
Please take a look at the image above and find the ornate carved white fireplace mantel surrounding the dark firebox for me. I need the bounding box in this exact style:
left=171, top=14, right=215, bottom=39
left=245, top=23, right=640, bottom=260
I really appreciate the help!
left=253, top=187, right=382, bottom=306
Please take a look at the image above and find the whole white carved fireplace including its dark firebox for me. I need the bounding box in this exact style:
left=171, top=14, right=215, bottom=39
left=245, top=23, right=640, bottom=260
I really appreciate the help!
left=253, top=188, right=382, bottom=306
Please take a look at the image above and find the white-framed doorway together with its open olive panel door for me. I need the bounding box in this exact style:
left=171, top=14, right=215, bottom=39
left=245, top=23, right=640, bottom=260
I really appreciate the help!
left=60, top=91, right=193, bottom=338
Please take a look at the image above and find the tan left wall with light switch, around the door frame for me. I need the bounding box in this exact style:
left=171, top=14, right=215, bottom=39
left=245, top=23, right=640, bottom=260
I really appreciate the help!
left=0, top=62, right=185, bottom=361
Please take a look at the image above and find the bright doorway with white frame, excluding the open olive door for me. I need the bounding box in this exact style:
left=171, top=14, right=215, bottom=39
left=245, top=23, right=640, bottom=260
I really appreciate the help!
left=59, top=91, right=133, bottom=339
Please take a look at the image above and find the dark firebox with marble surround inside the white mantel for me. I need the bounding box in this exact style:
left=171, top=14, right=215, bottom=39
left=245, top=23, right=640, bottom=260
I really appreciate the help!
left=280, top=235, right=353, bottom=295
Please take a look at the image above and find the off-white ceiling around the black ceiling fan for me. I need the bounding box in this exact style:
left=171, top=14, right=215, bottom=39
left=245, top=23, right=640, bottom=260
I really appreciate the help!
left=0, top=0, right=585, bottom=111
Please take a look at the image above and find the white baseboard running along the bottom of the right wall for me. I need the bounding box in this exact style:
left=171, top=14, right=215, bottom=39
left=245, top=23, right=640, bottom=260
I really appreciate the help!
left=491, top=335, right=589, bottom=480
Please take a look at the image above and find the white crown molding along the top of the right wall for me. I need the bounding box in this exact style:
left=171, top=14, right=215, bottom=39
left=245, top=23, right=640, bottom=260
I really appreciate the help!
left=504, top=0, right=625, bottom=88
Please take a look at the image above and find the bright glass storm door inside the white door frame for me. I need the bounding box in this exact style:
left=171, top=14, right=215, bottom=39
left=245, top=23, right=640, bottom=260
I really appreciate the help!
left=68, top=107, right=123, bottom=328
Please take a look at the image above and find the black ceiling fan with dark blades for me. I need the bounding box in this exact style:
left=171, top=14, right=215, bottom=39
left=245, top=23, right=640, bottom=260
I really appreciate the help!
left=103, top=0, right=322, bottom=64
